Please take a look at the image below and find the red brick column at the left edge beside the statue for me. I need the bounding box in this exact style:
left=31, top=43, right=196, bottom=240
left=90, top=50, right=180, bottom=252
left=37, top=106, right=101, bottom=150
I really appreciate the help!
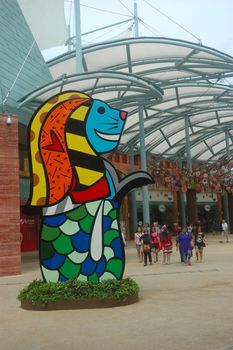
left=0, top=115, right=21, bottom=276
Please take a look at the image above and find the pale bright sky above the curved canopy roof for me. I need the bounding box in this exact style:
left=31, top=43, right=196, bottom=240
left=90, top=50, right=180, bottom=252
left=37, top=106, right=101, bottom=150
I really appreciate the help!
left=42, top=0, right=233, bottom=60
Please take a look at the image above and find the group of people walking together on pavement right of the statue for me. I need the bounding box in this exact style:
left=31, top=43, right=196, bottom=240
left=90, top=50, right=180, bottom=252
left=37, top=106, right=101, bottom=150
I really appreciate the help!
left=134, top=222, right=210, bottom=266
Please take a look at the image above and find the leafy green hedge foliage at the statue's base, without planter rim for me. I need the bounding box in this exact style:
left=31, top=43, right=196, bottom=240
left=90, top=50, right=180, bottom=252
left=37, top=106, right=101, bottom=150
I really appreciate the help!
left=18, top=278, right=139, bottom=303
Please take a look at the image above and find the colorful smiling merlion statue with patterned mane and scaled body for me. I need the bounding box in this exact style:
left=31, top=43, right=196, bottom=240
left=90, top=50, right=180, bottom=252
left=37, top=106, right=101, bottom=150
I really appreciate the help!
left=26, top=91, right=153, bottom=282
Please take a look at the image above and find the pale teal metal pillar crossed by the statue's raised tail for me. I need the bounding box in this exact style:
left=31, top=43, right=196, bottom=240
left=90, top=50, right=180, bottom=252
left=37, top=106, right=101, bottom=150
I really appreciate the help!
left=138, top=106, right=150, bottom=224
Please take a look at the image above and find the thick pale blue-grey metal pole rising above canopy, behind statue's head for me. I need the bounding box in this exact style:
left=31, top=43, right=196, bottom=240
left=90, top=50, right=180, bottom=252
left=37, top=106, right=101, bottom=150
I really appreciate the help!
left=74, top=0, right=83, bottom=73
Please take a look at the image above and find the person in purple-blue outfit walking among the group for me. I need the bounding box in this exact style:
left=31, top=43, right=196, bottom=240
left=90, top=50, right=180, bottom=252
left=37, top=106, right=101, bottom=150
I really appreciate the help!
left=177, top=227, right=193, bottom=266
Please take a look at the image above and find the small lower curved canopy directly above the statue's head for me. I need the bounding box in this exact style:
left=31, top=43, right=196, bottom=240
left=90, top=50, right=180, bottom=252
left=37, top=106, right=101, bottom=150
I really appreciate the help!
left=19, top=70, right=163, bottom=112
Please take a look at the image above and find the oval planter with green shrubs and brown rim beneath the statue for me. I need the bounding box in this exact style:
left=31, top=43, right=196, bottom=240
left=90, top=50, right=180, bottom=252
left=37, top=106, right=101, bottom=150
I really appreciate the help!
left=18, top=278, right=139, bottom=310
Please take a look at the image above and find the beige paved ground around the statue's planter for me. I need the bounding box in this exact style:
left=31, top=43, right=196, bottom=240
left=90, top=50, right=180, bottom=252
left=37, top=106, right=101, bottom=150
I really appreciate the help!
left=0, top=236, right=233, bottom=350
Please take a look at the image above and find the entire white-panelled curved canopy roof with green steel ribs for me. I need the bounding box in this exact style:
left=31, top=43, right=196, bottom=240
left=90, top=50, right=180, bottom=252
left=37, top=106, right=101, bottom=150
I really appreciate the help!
left=18, top=38, right=233, bottom=162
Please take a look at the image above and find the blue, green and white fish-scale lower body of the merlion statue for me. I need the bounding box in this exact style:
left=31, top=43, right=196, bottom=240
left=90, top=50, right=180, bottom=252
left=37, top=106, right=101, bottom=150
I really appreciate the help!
left=40, top=200, right=125, bottom=282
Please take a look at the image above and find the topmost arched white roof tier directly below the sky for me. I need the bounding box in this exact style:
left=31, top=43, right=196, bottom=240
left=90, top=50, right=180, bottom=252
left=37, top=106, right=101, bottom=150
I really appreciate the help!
left=48, top=37, right=233, bottom=86
